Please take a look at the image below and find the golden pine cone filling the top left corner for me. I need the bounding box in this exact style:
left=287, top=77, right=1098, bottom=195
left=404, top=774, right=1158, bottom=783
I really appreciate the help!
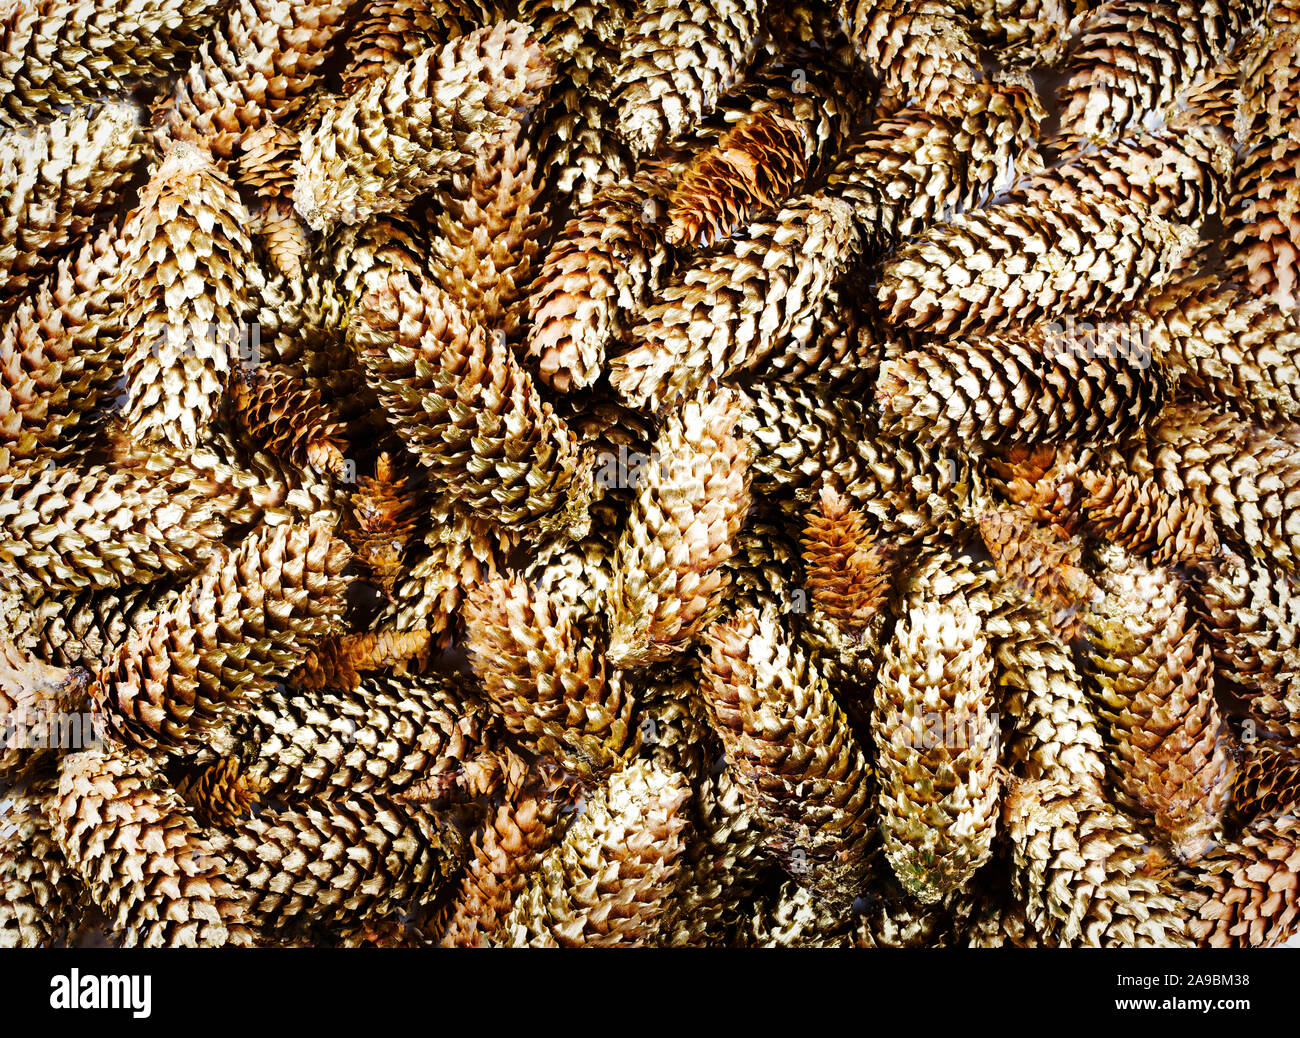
left=0, top=0, right=225, bottom=126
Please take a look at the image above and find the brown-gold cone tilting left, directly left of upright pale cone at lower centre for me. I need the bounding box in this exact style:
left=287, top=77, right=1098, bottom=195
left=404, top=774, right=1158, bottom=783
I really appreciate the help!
left=703, top=609, right=872, bottom=905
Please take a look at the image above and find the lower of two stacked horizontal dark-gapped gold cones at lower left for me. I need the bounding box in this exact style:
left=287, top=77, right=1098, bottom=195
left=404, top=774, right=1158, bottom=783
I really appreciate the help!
left=230, top=793, right=462, bottom=931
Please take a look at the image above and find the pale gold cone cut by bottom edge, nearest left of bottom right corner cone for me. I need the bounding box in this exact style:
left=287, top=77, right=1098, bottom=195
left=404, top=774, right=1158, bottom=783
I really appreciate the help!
left=1004, top=782, right=1188, bottom=948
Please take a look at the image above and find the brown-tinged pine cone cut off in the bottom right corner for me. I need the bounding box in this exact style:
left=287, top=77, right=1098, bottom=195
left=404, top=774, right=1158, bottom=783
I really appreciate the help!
left=1179, top=812, right=1300, bottom=948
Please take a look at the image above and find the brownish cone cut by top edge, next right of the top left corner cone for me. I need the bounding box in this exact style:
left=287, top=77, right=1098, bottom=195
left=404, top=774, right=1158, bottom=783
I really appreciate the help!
left=157, top=0, right=350, bottom=159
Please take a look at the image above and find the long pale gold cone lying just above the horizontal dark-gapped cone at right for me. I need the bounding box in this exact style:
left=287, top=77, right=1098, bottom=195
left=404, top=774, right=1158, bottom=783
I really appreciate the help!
left=880, top=196, right=1195, bottom=334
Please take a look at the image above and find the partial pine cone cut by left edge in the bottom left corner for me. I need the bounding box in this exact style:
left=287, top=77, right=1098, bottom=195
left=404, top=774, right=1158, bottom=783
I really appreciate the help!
left=0, top=779, right=86, bottom=948
